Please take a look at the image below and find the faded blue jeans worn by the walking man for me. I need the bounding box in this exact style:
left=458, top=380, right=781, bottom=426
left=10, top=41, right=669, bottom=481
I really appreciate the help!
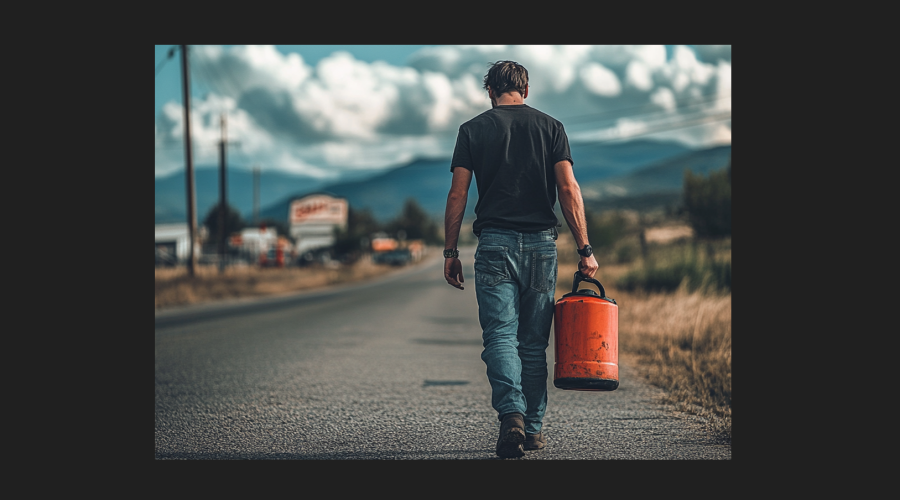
left=475, top=228, right=558, bottom=434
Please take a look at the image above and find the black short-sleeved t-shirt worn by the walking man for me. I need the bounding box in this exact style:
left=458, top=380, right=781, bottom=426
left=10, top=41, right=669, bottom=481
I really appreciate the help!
left=450, top=104, right=574, bottom=235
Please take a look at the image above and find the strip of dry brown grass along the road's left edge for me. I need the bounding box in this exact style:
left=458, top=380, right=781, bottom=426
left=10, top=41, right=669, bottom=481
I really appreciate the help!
left=156, top=251, right=435, bottom=309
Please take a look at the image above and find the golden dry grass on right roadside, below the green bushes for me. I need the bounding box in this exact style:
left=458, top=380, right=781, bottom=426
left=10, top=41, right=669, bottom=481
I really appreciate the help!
left=556, top=231, right=731, bottom=438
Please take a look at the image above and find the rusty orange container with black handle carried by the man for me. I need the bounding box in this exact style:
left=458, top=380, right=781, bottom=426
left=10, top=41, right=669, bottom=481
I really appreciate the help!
left=553, top=272, right=619, bottom=391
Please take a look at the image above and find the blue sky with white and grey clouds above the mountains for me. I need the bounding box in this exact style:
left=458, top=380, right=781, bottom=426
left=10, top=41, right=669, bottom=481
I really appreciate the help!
left=155, top=45, right=731, bottom=179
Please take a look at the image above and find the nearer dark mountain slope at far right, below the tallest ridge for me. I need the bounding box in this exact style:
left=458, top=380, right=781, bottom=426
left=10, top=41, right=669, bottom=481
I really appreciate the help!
left=581, top=145, right=731, bottom=207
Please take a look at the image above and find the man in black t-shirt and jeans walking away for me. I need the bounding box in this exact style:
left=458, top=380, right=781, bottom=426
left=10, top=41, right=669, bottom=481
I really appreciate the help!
left=444, top=61, right=598, bottom=458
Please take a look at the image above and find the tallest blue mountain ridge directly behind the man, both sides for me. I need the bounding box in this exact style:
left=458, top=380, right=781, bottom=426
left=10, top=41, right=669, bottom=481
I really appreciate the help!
left=262, top=140, right=693, bottom=221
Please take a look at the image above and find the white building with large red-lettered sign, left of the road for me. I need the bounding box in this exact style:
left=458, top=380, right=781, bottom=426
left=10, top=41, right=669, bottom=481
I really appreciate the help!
left=288, top=193, right=349, bottom=255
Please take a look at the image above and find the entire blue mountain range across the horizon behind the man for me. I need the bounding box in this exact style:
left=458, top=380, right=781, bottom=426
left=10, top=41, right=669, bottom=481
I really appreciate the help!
left=156, top=140, right=731, bottom=224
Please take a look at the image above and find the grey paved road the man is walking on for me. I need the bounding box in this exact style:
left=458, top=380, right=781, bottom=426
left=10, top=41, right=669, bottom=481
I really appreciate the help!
left=155, top=249, right=731, bottom=460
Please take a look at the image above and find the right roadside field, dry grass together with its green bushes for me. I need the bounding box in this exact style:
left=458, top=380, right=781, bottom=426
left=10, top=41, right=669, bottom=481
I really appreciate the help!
left=556, top=226, right=731, bottom=438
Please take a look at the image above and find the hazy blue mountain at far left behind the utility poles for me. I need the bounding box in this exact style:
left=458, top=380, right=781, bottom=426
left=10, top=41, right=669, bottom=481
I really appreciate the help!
left=155, top=166, right=324, bottom=224
